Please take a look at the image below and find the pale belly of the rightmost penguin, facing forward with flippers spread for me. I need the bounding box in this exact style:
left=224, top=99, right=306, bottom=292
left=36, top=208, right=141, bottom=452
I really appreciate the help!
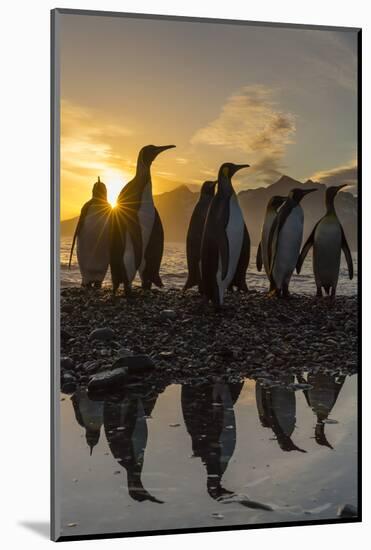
left=313, top=217, right=342, bottom=287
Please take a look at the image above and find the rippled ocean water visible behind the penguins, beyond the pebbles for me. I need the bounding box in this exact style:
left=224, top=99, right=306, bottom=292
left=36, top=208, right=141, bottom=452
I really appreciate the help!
left=60, top=237, right=357, bottom=296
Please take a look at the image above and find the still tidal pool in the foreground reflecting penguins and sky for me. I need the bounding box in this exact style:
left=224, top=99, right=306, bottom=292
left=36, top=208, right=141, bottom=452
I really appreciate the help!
left=58, top=374, right=357, bottom=537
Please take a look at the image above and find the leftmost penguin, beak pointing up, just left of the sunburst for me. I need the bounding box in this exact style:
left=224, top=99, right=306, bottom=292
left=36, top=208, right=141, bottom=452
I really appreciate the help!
left=69, top=178, right=111, bottom=288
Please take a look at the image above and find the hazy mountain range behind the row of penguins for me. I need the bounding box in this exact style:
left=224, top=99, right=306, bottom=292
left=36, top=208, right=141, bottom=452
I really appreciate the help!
left=61, top=176, right=357, bottom=250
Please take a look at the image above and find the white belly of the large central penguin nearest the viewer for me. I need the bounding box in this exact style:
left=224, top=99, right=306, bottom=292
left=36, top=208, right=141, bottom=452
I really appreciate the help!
left=216, top=194, right=245, bottom=304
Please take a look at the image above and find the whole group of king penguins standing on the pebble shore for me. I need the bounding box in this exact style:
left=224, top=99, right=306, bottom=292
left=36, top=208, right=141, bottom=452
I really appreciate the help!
left=69, top=145, right=353, bottom=309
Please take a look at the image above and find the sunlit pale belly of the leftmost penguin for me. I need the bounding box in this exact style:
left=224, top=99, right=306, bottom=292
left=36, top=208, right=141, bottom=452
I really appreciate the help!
left=77, top=205, right=110, bottom=285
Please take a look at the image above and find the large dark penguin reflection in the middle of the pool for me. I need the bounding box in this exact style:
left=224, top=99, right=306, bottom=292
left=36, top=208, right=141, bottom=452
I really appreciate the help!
left=181, top=382, right=243, bottom=500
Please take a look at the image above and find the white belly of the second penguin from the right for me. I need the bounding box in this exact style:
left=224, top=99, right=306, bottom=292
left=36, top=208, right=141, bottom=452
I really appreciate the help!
left=272, top=205, right=304, bottom=289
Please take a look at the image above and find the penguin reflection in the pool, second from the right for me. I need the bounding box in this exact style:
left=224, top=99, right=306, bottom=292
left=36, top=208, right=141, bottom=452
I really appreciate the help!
left=255, top=376, right=306, bottom=453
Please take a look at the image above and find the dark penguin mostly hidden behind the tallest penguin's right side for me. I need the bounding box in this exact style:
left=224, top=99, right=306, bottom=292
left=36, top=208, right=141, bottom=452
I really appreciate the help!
left=141, top=208, right=164, bottom=288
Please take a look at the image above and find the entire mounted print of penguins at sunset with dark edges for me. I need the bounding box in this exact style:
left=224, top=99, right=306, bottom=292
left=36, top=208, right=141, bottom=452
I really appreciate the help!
left=52, top=9, right=361, bottom=540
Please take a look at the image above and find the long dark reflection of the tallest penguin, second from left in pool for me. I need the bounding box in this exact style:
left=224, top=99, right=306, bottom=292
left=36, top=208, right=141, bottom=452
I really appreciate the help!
left=104, top=387, right=163, bottom=504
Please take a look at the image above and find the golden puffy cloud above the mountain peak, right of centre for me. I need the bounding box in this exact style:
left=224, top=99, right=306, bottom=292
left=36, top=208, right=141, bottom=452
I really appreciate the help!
left=191, top=86, right=296, bottom=184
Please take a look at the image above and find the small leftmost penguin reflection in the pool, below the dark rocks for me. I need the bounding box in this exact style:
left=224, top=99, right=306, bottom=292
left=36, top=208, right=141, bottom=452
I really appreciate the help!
left=71, top=389, right=103, bottom=454
